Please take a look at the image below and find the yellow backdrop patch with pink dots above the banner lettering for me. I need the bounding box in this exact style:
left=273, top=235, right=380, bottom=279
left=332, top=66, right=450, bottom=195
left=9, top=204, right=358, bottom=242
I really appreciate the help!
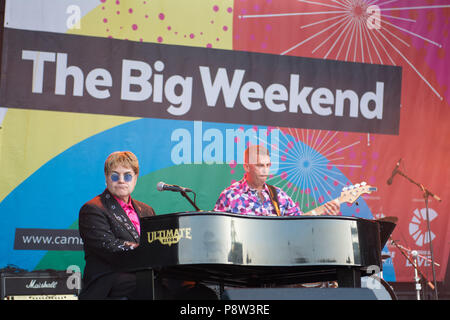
left=68, top=0, right=233, bottom=50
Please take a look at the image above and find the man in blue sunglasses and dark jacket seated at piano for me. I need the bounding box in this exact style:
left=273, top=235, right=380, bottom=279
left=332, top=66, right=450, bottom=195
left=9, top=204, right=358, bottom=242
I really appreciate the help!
left=78, top=151, right=155, bottom=299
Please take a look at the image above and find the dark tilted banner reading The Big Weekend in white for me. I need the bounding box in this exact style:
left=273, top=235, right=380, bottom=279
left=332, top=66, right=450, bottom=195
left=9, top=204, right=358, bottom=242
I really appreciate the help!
left=0, top=29, right=401, bottom=134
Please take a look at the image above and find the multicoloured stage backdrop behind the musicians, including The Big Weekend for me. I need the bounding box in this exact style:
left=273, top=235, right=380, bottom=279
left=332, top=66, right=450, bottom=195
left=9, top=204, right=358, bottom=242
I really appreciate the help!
left=0, top=0, right=450, bottom=281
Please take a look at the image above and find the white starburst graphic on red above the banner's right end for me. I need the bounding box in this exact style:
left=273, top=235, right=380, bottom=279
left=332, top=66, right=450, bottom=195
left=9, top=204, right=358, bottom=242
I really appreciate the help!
left=238, top=0, right=450, bottom=100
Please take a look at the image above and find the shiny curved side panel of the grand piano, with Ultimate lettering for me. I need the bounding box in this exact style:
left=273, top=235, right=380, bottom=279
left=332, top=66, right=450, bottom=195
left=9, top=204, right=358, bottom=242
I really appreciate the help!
left=131, top=212, right=392, bottom=266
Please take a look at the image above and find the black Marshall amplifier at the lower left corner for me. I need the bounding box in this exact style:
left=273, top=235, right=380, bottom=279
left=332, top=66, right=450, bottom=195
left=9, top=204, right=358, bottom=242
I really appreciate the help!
left=0, top=270, right=78, bottom=300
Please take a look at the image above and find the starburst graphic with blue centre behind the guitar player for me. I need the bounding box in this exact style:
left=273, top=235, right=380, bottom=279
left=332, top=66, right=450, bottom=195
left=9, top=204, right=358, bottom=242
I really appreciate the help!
left=268, top=128, right=369, bottom=215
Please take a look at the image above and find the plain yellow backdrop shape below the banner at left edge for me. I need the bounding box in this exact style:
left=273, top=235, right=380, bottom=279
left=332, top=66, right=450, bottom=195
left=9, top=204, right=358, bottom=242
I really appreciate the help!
left=0, top=108, right=139, bottom=201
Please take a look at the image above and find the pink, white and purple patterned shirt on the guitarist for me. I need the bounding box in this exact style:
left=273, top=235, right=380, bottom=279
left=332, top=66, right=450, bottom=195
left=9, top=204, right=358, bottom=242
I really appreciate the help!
left=214, top=178, right=302, bottom=216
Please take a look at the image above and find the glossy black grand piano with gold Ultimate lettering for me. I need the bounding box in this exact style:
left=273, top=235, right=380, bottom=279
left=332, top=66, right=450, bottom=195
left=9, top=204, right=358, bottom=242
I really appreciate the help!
left=125, top=211, right=395, bottom=298
